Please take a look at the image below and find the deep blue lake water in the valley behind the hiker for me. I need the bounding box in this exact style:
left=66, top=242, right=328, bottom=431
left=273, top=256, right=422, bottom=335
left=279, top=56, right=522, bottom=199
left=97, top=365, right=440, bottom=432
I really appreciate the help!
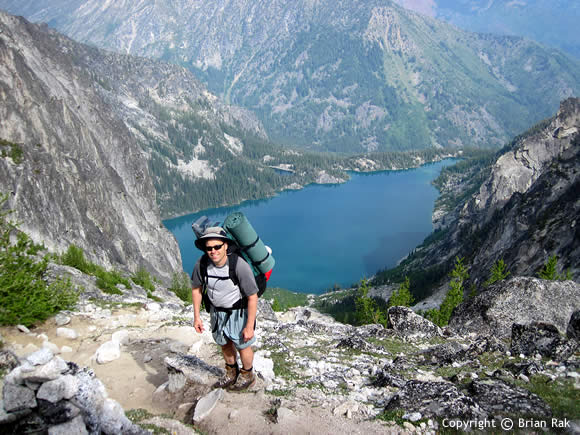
left=164, top=160, right=453, bottom=293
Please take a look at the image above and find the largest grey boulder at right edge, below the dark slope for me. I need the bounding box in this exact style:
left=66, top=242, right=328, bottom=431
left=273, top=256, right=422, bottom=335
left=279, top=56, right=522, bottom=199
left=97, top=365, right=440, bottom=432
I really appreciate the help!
left=449, top=277, right=580, bottom=339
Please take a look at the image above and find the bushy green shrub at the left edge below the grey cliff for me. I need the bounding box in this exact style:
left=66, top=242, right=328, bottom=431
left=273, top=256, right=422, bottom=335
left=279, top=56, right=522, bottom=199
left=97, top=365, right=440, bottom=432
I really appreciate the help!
left=0, top=195, right=79, bottom=326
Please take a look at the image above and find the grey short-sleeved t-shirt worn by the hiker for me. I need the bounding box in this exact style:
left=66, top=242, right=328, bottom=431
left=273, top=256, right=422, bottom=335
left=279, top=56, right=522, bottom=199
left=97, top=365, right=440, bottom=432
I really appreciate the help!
left=191, top=257, right=258, bottom=308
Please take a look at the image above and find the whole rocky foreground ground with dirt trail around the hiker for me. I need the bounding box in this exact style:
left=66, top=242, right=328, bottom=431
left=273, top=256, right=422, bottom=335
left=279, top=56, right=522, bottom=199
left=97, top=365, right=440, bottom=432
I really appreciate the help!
left=0, top=272, right=580, bottom=434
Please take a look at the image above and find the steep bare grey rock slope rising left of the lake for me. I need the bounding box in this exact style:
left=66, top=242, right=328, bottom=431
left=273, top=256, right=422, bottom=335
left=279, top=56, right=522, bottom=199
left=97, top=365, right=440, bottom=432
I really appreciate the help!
left=0, top=13, right=181, bottom=278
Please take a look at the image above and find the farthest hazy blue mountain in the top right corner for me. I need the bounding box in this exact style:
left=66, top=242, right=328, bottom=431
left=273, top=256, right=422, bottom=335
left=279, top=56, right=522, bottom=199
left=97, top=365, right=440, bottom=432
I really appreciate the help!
left=396, top=0, right=580, bottom=57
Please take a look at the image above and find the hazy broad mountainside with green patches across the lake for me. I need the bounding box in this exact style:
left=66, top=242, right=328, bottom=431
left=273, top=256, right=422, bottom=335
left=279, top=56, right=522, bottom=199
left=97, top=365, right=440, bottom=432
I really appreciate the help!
left=0, top=0, right=580, bottom=152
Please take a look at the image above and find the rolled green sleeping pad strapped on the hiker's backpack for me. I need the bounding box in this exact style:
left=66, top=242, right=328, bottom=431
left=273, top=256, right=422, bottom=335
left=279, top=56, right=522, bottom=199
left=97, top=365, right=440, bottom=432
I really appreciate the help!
left=224, top=212, right=276, bottom=274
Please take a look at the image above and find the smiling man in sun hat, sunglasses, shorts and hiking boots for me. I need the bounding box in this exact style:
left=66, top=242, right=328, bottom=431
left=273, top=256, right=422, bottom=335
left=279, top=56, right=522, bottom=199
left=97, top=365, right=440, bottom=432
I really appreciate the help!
left=191, top=227, right=258, bottom=390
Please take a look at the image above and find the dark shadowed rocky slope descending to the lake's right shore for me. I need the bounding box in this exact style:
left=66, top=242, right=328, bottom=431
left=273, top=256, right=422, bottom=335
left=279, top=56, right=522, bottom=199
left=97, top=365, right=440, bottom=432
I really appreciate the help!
left=380, top=98, right=580, bottom=298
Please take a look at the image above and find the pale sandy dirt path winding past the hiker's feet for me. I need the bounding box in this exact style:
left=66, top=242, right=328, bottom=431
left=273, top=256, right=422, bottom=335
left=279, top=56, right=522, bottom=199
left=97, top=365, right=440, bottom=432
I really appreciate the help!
left=0, top=308, right=401, bottom=435
